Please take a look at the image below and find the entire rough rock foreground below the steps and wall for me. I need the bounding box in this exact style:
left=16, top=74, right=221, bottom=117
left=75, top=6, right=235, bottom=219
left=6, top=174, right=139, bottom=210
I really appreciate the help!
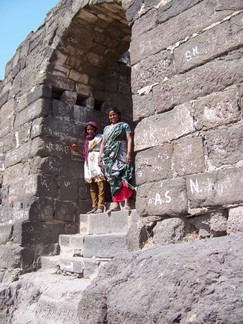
left=0, top=235, right=243, bottom=324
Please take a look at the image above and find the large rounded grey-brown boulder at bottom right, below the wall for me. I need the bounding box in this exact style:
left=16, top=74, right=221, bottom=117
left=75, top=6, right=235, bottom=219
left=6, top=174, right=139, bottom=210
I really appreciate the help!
left=79, top=236, right=243, bottom=324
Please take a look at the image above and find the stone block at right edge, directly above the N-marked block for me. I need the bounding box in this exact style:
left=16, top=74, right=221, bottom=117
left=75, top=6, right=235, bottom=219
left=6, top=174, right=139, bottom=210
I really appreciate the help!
left=206, top=124, right=243, bottom=168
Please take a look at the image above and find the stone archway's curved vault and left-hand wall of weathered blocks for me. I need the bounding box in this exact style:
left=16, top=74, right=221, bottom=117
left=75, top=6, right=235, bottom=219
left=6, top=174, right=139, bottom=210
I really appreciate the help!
left=0, top=0, right=132, bottom=269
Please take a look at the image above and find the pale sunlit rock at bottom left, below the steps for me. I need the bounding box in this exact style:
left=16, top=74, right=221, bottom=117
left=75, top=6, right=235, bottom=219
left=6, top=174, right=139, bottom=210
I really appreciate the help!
left=0, top=272, right=90, bottom=324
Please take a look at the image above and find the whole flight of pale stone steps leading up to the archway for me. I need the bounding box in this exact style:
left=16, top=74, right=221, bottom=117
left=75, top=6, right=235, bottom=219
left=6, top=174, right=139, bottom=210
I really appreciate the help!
left=41, top=209, right=141, bottom=279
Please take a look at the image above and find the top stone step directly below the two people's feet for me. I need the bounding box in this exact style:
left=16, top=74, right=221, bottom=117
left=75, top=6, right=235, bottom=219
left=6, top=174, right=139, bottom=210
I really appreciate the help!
left=80, top=210, right=132, bottom=235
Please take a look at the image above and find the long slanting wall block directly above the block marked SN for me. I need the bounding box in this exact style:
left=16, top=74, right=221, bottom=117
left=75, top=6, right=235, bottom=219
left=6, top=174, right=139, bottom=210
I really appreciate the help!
left=131, top=0, right=238, bottom=64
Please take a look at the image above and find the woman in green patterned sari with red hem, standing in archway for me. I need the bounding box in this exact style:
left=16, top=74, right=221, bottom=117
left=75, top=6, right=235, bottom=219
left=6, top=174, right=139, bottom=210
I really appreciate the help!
left=99, top=108, right=134, bottom=212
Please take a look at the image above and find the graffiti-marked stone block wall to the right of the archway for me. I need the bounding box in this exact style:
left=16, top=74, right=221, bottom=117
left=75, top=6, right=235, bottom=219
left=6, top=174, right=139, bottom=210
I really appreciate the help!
left=130, top=0, right=243, bottom=238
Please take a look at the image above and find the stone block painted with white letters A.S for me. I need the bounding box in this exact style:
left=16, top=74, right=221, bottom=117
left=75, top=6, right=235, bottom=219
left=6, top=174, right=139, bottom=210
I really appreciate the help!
left=136, top=178, right=187, bottom=216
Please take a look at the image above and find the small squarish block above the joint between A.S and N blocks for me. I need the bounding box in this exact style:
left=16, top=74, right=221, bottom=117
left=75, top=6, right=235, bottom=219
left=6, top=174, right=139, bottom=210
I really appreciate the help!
left=173, top=137, right=205, bottom=176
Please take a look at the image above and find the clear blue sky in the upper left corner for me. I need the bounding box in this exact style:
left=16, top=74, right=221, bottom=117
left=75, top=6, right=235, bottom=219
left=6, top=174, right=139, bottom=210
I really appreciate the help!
left=0, top=0, right=59, bottom=80
